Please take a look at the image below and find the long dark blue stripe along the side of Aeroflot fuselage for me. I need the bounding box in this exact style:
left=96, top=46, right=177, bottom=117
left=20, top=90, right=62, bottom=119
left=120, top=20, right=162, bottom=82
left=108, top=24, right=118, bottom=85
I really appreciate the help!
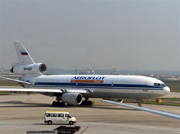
left=34, top=82, right=165, bottom=90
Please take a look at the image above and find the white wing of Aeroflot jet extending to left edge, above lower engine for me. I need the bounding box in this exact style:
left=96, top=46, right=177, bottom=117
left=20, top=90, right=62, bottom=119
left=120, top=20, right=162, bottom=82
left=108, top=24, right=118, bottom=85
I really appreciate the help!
left=0, top=88, right=90, bottom=94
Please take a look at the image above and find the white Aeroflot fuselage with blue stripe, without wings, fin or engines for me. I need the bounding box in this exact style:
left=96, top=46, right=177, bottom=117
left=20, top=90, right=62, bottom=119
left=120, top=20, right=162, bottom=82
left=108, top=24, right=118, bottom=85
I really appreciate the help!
left=21, top=75, right=170, bottom=99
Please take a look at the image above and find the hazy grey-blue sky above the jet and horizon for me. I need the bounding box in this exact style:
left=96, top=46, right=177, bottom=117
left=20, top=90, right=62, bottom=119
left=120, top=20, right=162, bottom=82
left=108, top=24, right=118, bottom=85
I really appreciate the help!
left=0, top=0, right=180, bottom=71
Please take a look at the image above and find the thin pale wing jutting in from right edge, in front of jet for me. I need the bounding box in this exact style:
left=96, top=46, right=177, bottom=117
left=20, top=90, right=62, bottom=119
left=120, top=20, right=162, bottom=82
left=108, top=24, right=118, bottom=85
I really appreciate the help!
left=103, top=100, right=180, bottom=120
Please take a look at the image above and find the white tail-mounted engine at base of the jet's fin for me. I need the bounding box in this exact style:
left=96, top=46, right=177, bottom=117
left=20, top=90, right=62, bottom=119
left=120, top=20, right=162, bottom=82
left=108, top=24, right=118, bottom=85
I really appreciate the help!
left=10, top=63, right=47, bottom=75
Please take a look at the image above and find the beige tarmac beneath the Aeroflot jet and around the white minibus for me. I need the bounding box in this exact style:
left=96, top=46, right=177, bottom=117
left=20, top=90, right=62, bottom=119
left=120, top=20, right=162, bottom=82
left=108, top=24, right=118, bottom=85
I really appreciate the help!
left=0, top=94, right=180, bottom=134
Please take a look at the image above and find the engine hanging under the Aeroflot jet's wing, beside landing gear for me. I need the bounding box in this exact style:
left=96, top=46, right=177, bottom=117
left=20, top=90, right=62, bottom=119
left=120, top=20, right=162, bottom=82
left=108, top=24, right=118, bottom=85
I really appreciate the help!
left=62, top=93, right=83, bottom=106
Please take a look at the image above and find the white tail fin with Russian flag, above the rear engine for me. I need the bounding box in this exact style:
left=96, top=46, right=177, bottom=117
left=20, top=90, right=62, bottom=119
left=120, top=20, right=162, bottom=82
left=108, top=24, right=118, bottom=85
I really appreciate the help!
left=14, top=41, right=35, bottom=65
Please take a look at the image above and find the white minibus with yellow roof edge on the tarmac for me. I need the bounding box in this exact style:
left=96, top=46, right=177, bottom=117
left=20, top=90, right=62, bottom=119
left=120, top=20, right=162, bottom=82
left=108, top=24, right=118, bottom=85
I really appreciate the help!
left=44, top=111, right=77, bottom=125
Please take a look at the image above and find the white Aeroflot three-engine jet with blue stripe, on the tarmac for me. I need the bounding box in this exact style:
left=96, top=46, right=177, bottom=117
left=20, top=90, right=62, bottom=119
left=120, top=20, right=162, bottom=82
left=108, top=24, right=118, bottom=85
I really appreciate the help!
left=0, top=41, right=179, bottom=120
